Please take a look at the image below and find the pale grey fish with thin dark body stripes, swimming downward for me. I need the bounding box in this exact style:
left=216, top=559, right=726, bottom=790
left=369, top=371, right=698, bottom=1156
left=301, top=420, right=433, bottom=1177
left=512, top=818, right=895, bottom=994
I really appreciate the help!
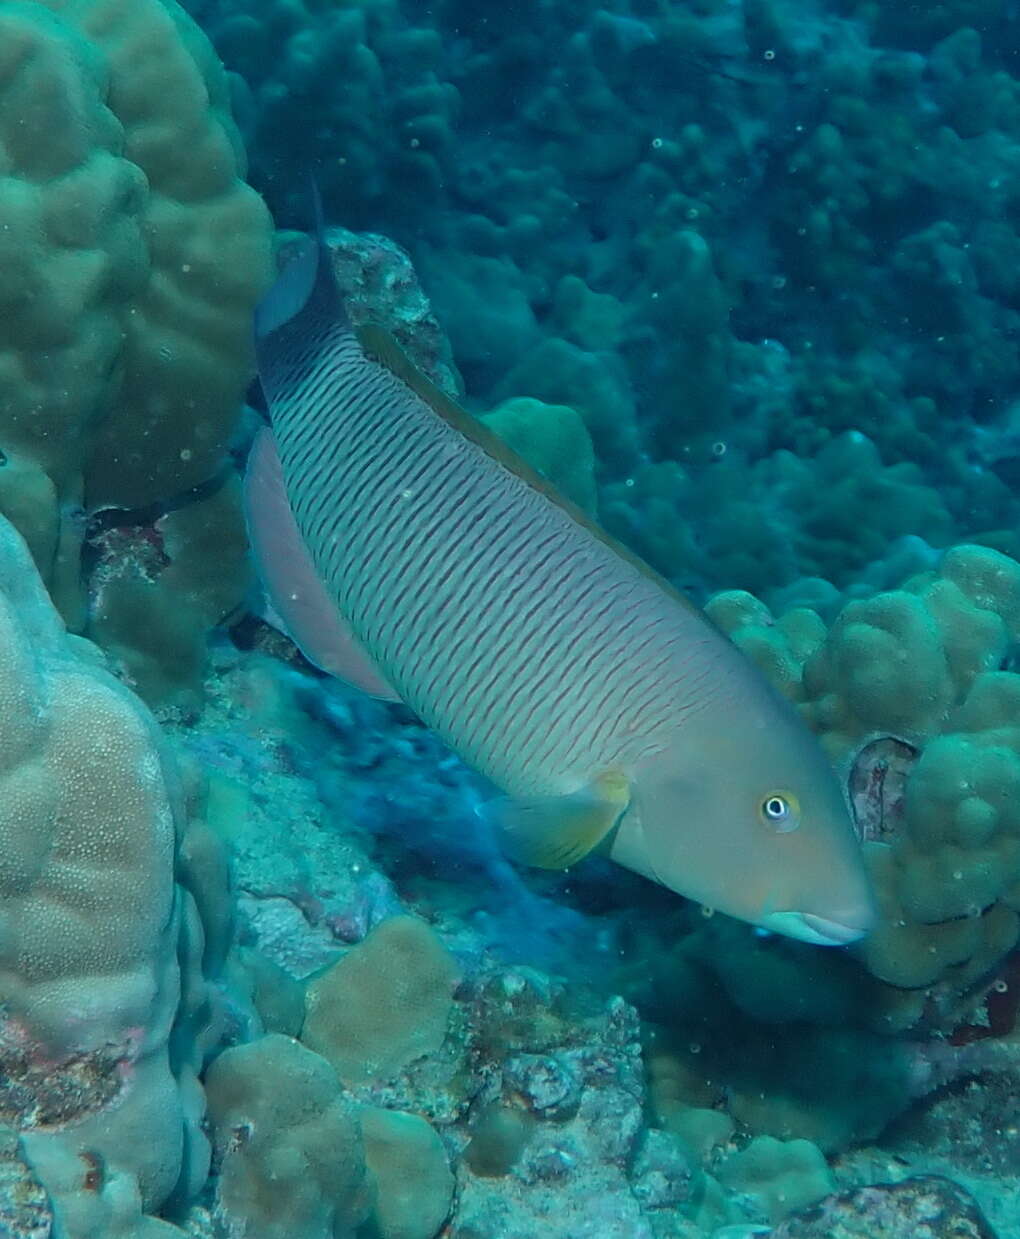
left=245, top=215, right=875, bottom=947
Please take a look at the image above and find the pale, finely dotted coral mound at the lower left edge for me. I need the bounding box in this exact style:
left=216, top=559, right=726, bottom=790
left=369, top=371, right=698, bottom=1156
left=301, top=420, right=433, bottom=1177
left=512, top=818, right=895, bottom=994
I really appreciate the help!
left=0, top=520, right=208, bottom=1239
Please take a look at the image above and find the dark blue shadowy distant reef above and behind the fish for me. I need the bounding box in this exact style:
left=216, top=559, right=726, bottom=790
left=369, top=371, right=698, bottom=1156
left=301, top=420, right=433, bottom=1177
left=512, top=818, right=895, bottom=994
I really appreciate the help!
left=191, top=0, right=1020, bottom=601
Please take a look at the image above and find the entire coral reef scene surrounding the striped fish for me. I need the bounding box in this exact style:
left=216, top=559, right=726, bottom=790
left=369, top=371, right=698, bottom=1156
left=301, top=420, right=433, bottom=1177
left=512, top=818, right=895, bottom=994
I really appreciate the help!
left=0, top=0, right=1020, bottom=1239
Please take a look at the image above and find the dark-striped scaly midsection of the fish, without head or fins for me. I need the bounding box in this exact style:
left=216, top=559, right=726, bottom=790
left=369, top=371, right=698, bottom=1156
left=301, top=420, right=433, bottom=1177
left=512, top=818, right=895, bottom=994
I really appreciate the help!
left=262, top=308, right=732, bottom=797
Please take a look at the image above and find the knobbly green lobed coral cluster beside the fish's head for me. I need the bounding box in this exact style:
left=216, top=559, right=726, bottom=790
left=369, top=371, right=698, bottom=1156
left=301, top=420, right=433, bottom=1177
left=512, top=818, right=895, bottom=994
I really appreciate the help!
left=709, top=546, right=1020, bottom=1026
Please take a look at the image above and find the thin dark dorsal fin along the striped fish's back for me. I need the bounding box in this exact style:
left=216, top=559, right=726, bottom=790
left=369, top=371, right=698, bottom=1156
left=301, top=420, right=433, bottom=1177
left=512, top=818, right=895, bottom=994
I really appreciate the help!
left=354, top=323, right=711, bottom=624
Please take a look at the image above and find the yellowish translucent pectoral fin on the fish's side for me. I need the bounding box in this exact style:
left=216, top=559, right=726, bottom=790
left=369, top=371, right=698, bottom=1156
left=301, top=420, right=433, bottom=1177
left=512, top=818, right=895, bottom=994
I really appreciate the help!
left=490, top=771, right=630, bottom=869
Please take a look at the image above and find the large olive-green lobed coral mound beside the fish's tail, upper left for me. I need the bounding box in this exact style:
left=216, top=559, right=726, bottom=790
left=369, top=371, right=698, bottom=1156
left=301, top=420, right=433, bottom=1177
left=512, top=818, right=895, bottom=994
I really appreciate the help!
left=0, top=0, right=270, bottom=622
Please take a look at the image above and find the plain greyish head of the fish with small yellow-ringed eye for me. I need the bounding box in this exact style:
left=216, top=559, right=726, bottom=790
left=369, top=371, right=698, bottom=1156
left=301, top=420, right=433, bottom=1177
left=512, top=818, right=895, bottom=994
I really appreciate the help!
left=622, top=683, right=875, bottom=945
